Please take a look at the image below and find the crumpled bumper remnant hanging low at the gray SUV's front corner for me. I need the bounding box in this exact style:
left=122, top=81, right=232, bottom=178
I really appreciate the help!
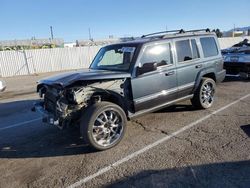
left=31, top=102, right=60, bottom=127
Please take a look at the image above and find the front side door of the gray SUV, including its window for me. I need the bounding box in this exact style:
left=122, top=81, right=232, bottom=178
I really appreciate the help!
left=131, top=42, right=178, bottom=112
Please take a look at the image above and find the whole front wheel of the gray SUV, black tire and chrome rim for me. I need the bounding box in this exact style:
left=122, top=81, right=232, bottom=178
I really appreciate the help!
left=80, top=102, right=127, bottom=150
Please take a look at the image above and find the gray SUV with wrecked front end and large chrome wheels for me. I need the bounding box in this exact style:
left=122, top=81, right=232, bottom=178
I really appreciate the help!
left=33, top=30, right=225, bottom=150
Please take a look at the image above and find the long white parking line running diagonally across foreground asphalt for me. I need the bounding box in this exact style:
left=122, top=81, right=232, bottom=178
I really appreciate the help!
left=68, top=94, right=250, bottom=188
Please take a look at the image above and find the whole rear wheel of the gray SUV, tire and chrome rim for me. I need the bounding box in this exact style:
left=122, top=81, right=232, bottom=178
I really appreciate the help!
left=191, top=78, right=216, bottom=109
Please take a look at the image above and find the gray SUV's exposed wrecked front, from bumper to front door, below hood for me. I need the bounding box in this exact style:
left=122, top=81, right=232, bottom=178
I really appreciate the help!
left=32, top=79, right=127, bottom=129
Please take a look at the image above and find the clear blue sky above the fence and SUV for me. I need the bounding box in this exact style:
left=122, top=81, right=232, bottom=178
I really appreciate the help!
left=0, top=0, right=250, bottom=42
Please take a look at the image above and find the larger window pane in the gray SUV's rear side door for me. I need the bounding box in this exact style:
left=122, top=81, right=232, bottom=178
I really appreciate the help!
left=175, top=40, right=193, bottom=62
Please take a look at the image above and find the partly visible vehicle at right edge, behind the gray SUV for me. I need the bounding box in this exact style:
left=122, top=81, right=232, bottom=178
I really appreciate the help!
left=222, top=39, right=250, bottom=78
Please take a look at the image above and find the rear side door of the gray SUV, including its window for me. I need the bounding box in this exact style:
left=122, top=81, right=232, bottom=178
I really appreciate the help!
left=174, top=38, right=203, bottom=98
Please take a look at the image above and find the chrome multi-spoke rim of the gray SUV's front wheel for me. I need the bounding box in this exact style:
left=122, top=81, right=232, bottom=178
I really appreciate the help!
left=92, top=109, right=123, bottom=147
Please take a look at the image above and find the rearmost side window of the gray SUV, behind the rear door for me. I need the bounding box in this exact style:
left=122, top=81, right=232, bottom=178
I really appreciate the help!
left=200, top=37, right=219, bottom=57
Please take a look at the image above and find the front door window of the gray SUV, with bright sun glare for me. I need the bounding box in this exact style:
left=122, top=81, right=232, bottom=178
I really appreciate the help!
left=140, top=43, right=173, bottom=66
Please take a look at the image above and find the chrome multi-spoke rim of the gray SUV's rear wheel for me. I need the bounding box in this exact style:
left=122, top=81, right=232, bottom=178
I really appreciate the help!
left=201, top=82, right=215, bottom=106
